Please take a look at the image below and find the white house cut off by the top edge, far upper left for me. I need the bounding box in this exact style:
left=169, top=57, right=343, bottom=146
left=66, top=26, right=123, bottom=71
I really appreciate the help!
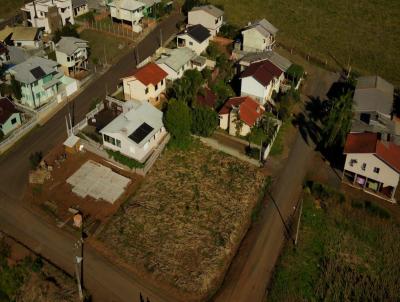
left=21, top=0, right=75, bottom=34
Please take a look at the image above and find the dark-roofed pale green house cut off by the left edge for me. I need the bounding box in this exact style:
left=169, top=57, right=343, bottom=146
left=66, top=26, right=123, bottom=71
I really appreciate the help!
left=0, top=98, right=22, bottom=135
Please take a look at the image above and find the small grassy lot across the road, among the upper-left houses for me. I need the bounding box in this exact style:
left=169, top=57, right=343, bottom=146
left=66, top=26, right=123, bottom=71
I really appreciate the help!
left=80, top=29, right=132, bottom=64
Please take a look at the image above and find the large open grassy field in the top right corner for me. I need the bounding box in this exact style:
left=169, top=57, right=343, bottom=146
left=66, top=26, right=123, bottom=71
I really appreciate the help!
left=210, top=0, right=400, bottom=85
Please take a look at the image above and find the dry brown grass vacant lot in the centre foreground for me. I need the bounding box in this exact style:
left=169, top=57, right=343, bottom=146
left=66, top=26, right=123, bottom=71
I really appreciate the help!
left=100, top=142, right=264, bottom=298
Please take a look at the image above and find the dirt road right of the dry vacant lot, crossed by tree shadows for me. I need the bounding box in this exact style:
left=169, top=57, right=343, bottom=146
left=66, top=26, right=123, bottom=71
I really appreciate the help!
left=214, top=69, right=337, bottom=302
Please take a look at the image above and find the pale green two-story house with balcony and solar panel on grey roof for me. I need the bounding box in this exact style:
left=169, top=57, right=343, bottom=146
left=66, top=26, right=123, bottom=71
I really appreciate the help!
left=7, top=56, right=78, bottom=109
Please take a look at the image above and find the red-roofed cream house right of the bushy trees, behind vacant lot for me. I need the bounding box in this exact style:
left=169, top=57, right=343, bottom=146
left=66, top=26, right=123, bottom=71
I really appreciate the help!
left=219, top=96, right=265, bottom=136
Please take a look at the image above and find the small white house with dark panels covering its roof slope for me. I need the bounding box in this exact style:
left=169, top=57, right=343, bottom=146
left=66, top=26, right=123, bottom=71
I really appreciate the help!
left=176, top=24, right=211, bottom=55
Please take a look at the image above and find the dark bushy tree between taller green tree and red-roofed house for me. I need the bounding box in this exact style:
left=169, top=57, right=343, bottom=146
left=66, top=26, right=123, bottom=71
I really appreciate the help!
left=192, top=106, right=218, bottom=136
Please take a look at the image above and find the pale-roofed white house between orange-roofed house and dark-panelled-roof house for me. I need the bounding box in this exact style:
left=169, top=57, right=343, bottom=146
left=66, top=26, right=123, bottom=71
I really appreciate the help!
left=156, top=47, right=206, bottom=81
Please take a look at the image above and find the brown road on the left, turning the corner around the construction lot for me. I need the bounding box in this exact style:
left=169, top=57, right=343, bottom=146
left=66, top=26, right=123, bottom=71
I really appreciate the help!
left=0, top=15, right=182, bottom=302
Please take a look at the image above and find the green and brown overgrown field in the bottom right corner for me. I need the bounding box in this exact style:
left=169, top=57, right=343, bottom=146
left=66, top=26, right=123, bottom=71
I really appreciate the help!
left=268, top=183, right=400, bottom=301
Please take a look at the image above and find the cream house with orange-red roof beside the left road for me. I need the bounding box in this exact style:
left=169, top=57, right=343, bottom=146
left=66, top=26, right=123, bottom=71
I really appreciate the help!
left=122, top=63, right=168, bottom=105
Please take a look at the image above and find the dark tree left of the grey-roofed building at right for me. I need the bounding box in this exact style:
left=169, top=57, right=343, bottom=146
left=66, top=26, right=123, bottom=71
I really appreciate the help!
left=322, top=92, right=353, bottom=148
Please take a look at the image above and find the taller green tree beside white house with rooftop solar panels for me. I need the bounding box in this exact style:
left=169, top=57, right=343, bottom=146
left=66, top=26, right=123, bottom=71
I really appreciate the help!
left=164, top=99, right=192, bottom=148
